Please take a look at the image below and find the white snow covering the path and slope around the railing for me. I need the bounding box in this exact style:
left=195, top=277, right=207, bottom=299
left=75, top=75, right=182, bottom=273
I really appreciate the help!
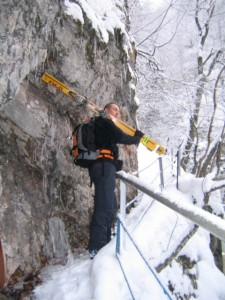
left=34, top=146, right=225, bottom=300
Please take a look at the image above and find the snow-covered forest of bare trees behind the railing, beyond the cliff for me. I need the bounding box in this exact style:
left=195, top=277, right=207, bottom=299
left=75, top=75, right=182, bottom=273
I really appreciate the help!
left=129, top=0, right=225, bottom=180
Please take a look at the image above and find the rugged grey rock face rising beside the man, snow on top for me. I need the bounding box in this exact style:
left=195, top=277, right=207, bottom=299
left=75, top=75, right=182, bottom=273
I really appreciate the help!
left=0, top=0, right=137, bottom=278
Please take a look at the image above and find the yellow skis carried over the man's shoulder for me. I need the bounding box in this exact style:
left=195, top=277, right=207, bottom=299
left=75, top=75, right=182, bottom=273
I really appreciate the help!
left=42, top=73, right=167, bottom=155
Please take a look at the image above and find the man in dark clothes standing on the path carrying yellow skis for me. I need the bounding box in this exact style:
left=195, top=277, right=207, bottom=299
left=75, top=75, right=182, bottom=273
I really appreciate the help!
left=89, top=102, right=144, bottom=259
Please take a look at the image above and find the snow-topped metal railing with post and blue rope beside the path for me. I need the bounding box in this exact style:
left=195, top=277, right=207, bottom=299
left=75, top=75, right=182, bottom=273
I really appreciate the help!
left=116, top=170, right=225, bottom=300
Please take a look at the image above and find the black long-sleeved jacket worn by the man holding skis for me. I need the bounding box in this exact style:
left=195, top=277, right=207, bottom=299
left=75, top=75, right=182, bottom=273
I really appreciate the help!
left=94, top=117, right=140, bottom=160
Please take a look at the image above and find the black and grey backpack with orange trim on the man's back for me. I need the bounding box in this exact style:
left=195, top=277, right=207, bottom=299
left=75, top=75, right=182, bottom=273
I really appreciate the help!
left=70, top=118, right=100, bottom=168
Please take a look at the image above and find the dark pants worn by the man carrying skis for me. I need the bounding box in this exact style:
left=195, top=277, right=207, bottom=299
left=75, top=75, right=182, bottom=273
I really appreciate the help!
left=89, top=161, right=117, bottom=250
